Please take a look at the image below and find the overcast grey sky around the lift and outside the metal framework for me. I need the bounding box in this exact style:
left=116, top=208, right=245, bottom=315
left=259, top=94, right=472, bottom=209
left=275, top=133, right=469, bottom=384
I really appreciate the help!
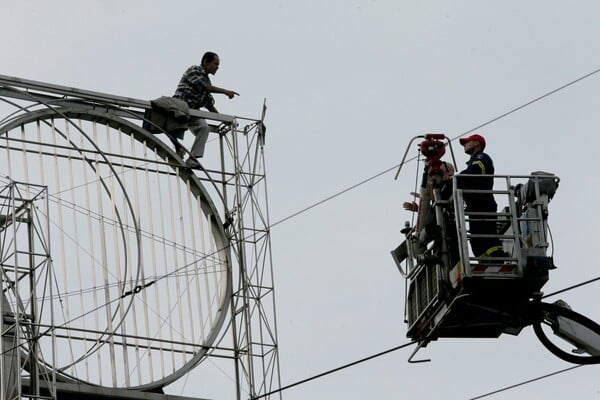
left=0, top=0, right=600, bottom=400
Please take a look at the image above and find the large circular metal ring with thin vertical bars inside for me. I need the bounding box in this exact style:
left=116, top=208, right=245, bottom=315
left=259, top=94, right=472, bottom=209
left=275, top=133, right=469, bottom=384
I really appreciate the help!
left=0, top=105, right=232, bottom=389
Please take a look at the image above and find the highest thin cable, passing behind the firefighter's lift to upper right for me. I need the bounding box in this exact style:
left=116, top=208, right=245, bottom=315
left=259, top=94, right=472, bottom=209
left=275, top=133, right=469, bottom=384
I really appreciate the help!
left=271, top=68, right=600, bottom=227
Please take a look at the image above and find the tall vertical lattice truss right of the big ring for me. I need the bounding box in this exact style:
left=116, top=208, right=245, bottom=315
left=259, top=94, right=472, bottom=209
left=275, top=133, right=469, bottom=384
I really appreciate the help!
left=221, top=106, right=281, bottom=398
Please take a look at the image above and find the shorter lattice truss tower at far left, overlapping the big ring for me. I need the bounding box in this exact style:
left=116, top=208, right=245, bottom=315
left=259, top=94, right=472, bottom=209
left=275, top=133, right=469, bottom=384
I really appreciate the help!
left=0, top=180, right=56, bottom=400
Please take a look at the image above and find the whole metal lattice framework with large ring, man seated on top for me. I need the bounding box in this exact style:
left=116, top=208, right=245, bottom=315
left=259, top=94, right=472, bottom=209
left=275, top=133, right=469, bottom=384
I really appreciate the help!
left=0, top=75, right=280, bottom=399
